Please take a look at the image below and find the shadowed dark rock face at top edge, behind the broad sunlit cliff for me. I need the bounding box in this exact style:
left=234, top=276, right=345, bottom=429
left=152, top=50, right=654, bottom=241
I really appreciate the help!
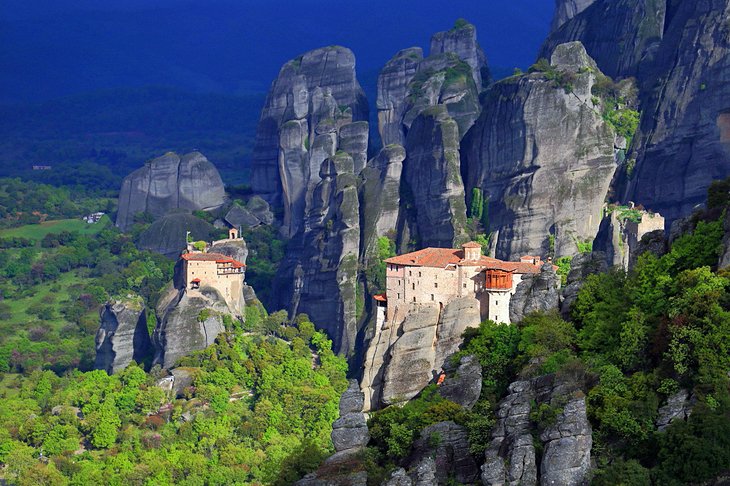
left=540, top=0, right=666, bottom=78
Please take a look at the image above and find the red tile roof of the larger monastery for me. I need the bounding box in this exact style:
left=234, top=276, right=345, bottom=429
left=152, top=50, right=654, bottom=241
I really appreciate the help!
left=385, top=248, right=540, bottom=273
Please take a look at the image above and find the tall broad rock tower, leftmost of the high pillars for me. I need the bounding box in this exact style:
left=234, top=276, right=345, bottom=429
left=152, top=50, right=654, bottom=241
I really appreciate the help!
left=251, top=46, right=368, bottom=236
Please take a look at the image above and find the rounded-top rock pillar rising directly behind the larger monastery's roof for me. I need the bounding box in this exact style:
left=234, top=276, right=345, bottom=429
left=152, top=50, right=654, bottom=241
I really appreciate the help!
left=404, top=105, right=466, bottom=248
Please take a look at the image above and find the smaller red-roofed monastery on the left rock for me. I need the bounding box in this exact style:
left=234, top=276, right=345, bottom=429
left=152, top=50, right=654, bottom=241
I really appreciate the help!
left=180, top=228, right=246, bottom=315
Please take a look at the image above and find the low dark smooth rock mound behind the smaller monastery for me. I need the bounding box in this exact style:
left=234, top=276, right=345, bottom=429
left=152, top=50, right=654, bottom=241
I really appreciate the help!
left=137, top=212, right=215, bottom=258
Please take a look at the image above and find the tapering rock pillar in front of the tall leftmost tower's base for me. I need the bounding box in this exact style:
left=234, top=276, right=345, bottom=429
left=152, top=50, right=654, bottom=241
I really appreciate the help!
left=274, top=152, right=360, bottom=353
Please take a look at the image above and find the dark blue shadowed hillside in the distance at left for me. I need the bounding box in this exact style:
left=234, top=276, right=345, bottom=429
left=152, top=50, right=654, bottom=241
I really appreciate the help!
left=0, top=87, right=264, bottom=190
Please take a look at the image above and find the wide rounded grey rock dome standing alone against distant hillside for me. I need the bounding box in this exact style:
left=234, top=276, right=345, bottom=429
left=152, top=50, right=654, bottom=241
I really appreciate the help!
left=116, top=152, right=225, bottom=231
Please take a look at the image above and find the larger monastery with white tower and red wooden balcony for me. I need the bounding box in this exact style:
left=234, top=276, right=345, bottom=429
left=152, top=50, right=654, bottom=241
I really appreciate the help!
left=375, top=242, right=543, bottom=327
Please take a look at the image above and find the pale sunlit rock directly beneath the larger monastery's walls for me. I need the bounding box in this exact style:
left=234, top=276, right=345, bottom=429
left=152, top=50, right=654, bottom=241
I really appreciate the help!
left=361, top=298, right=481, bottom=411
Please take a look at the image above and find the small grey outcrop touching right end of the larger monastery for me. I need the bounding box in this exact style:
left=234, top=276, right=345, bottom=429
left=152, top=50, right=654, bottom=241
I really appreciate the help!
left=509, top=263, right=560, bottom=323
